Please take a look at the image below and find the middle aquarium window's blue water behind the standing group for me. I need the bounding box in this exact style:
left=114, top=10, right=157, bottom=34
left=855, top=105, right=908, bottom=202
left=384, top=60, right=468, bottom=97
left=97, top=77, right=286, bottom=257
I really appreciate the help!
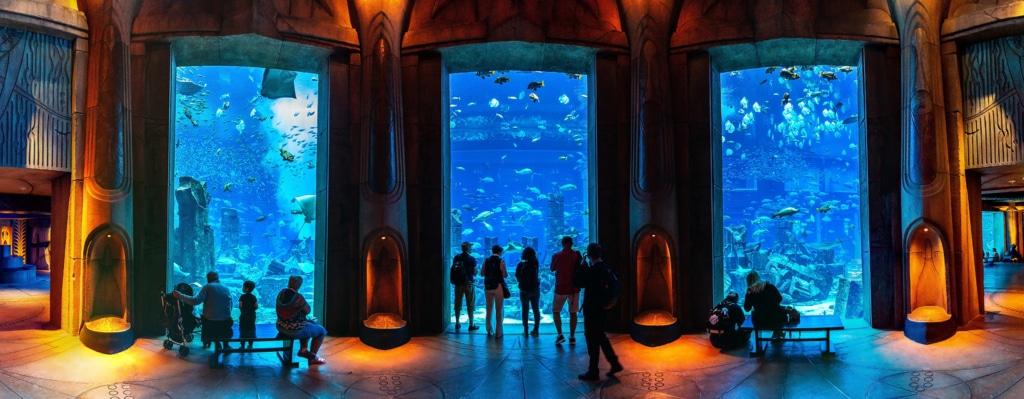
left=449, top=71, right=591, bottom=323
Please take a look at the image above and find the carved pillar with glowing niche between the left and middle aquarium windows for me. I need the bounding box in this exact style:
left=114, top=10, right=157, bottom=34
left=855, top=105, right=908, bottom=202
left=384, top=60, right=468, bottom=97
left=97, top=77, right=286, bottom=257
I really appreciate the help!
left=355, top=1, right=412, bottom=346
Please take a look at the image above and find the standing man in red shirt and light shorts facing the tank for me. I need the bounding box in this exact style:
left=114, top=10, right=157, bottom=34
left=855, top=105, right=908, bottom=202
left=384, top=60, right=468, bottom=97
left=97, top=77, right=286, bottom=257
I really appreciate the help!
left=551, top=235, right=583, bottom=345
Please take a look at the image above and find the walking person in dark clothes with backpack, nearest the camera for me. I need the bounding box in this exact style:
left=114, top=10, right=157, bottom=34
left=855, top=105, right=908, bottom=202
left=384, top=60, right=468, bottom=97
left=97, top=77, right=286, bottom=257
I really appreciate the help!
left=579, top=242, right=623, bottom=381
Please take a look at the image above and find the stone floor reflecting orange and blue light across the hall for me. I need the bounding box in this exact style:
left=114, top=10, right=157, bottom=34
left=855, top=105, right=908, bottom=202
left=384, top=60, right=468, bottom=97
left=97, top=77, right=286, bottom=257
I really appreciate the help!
left=0, top=266, right=1024, bottom=398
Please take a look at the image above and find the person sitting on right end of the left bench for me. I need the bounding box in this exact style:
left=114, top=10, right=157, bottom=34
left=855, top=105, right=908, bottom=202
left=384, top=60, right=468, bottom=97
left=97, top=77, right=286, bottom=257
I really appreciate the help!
left=276, top=275, right=327, bottom=365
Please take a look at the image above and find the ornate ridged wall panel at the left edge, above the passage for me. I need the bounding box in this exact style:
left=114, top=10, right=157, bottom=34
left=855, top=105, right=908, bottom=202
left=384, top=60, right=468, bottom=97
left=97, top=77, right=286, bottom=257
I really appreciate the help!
left=0, top=27, right=72, bottom=171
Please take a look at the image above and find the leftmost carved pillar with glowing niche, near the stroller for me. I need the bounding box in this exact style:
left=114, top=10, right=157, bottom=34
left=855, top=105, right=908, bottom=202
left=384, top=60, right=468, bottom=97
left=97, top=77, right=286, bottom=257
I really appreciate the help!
left=76, top=0, right=133, bottom=349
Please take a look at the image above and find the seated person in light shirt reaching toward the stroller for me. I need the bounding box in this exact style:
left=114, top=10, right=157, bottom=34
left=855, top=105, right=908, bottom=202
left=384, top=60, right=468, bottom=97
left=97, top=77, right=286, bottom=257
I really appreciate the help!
left=173, top=271, right=234, bottom=348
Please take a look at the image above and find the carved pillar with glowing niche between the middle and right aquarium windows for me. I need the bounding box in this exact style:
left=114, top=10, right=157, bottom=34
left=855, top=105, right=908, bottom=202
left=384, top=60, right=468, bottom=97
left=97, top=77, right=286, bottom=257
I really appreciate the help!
left=623, top=0, right=679, bottom=345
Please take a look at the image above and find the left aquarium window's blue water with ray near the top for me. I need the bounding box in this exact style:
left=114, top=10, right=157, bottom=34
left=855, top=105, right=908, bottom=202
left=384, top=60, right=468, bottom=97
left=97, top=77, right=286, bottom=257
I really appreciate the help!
left=168, top=67, right=318, bottom=323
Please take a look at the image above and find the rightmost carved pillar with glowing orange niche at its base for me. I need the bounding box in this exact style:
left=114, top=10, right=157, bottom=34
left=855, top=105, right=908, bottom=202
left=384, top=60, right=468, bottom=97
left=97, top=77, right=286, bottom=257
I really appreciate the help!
left=889, top=0, right=956, bottom=343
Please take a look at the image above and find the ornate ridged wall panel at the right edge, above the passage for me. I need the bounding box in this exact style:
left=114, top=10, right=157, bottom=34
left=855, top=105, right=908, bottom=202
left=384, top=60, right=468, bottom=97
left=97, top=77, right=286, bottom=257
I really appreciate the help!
left=961, top=36, right=1024, bottom=169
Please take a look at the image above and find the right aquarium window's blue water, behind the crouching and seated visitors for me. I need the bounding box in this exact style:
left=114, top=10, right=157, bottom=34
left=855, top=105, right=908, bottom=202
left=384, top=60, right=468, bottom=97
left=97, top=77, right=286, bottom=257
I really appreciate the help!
left=720, top=65, right=864, bottom=318
